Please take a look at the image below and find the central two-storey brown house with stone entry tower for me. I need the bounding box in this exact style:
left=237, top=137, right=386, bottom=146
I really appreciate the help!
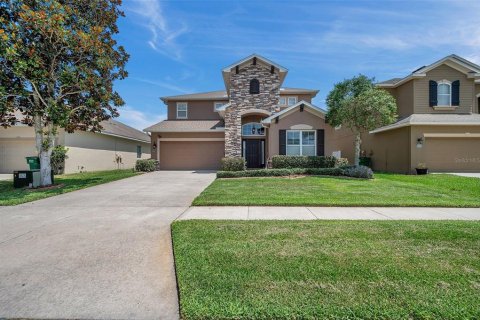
left=144, top=54, right=353, bottom=170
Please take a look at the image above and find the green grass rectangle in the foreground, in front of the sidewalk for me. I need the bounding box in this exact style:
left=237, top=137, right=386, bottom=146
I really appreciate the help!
left=172, top=220, right=480, bottom=319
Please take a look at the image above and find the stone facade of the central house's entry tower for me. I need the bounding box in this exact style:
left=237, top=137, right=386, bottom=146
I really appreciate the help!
left=225, top=62, right=281, bottom=157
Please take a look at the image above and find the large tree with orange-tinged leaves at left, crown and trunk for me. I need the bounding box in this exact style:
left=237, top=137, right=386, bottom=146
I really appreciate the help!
left=0, top=0, right=128, bottom=185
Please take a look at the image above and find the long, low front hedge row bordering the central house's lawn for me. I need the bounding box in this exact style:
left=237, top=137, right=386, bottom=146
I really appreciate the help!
left=217, top=168, right=344, bottom=178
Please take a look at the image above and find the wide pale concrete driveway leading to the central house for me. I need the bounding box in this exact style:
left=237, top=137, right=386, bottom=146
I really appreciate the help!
left=0, top=171, right=215, bottom=319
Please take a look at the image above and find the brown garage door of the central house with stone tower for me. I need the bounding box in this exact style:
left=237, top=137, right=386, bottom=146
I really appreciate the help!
left=160, top=141, right=225, bottom=170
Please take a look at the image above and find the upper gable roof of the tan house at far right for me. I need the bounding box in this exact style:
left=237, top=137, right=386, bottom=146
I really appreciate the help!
left=377, top=54, right=480, bottom=88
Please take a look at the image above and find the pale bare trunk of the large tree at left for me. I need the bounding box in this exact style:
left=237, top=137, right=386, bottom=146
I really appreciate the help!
left=33, top=115, right=55, bottom=187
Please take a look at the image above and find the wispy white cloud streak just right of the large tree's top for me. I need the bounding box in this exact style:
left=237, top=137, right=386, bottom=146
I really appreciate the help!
left=129, top=0, right=189, bottom=61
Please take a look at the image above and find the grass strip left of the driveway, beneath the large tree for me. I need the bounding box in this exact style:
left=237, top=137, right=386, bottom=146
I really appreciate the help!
left=0, top=169, right=138, bottom=206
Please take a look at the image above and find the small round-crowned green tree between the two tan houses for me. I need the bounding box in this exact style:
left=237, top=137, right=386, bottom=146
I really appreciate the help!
left=327, top=75, right=397, bottom=166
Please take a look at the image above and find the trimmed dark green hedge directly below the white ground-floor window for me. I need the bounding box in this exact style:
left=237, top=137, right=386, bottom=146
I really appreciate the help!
left=272, top=155, right=338, bottom=169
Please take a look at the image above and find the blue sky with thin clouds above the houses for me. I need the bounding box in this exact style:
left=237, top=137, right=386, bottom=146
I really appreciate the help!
left=116, top=0, right=480, bottom=129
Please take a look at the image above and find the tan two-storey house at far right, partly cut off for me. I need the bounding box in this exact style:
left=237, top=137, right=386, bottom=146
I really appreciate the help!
left=362, top=55, right=480, bottom=173
